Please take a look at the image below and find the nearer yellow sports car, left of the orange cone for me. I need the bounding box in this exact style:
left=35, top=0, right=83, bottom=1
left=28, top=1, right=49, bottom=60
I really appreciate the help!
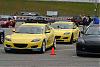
left=4, top=23, right=56, bottom=53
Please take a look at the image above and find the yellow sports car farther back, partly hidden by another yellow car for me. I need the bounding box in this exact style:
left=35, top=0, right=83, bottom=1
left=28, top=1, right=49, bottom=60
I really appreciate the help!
left=51, top=21, right=80, bottom=43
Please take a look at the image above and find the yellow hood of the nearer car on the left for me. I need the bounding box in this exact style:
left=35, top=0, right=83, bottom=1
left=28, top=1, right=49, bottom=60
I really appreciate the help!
left=6, top=33, right=44, bottom=43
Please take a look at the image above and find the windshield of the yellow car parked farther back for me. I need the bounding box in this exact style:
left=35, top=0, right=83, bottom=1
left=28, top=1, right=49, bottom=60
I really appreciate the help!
left=51, top=23, right=73, bottom=29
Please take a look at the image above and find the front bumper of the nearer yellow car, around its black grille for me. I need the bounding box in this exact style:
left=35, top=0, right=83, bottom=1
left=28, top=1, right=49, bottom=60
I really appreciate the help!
left=4, top=41, right=42, bottom=51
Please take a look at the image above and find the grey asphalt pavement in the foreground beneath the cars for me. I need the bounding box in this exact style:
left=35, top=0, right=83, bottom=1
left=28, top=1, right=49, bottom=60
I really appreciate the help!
left=0, top=44, right=100, bottom=67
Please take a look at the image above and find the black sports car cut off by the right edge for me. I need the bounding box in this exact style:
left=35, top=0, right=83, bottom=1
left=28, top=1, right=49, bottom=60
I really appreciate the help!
left=76, top=24, right=100, bottom=56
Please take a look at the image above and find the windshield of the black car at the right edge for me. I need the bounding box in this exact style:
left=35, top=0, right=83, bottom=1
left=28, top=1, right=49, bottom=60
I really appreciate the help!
left=85, top=27, right=100, bottom=35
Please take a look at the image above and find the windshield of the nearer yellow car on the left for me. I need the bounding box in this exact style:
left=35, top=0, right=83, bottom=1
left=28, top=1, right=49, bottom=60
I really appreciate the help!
left=16, top=26, right=43, bottom=34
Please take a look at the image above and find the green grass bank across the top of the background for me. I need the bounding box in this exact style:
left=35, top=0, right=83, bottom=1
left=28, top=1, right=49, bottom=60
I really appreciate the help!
left=0, top=0, right=100, bottom=16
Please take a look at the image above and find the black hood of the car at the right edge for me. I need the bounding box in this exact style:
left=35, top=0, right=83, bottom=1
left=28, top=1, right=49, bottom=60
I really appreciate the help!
left=83, top=35, right=100, bottom=45
